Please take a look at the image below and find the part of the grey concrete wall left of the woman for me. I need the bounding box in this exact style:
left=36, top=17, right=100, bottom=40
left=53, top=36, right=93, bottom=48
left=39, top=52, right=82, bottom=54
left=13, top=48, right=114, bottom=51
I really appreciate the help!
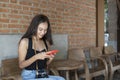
left=0, top=35, right=21, bottom=65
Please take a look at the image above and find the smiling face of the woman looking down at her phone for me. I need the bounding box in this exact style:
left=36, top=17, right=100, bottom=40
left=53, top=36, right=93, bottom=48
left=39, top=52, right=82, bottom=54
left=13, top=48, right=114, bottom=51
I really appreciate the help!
left=37, top=22, right=48, bottom=39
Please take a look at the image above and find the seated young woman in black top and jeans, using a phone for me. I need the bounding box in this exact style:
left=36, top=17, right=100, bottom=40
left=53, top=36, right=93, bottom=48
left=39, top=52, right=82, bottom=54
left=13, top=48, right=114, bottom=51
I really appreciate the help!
left=18, top=14, right=65, bottom=80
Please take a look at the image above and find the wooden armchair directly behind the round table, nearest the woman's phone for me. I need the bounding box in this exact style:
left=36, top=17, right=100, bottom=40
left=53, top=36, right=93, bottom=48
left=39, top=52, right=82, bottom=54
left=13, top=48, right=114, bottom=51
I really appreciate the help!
left=68, top=48, right=90, bottom=80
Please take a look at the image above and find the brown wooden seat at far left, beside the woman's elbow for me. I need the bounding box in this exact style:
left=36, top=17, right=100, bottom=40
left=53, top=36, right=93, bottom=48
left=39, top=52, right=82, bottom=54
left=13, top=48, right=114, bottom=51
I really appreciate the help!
left=1, top=58, right=22, bottom=80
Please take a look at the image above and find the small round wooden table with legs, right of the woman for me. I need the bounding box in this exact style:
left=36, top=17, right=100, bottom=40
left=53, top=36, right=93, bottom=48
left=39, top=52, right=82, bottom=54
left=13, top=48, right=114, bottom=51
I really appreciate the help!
left=50, top=60, right=84, bottom=80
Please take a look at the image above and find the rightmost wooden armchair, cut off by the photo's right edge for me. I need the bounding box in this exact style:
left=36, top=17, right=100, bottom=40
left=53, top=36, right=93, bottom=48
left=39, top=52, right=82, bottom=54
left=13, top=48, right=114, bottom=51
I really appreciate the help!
left=104, top=46, right=120, bottom=80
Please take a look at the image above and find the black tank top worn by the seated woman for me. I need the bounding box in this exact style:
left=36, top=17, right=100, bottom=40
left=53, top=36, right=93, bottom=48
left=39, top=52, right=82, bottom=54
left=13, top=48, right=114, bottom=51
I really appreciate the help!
left=25, top=38, right=48, bottom=70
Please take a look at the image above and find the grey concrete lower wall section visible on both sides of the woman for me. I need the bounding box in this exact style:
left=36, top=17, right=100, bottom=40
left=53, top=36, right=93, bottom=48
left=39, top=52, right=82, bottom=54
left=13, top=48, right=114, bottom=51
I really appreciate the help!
left=0, top=34, right=68, bottom=66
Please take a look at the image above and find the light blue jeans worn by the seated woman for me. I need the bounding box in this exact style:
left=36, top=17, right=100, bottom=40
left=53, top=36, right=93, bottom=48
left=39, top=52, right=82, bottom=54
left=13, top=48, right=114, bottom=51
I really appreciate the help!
left=21, top=69, right=65, bottom=80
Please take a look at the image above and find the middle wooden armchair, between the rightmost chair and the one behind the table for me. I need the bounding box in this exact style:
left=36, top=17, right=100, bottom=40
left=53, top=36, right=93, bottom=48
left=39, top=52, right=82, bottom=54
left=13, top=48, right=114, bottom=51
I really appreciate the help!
left=90, top=47, right=108, bottom=80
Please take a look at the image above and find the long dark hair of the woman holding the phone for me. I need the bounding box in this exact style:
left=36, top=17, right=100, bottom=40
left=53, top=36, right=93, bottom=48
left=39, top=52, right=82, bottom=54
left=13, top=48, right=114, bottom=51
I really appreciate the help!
left=20, top=14, right=53, bottom=45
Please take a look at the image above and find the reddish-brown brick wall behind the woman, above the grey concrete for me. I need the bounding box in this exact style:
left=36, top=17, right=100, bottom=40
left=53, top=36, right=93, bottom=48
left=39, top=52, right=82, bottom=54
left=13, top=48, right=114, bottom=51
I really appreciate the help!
left=0, top=0, right=96, bottom=48
